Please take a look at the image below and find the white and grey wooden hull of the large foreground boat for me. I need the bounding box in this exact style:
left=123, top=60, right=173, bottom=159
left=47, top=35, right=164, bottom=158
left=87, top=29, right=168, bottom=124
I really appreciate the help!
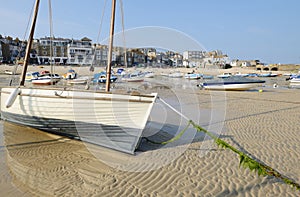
left=1, top=88, right=156, bottom=154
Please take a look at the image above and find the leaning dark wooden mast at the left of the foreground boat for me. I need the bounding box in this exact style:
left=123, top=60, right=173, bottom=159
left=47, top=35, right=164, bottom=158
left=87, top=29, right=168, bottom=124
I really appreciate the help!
left=20, top=0, right=40, bottom=86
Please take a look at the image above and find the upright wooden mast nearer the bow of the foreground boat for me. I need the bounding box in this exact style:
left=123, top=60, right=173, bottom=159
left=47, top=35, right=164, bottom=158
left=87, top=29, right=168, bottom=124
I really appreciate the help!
left=105, top=0, right=116, bottom=92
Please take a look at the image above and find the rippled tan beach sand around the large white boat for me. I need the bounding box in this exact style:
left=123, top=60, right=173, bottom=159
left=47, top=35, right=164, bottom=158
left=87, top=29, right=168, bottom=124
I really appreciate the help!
left=0, top=66, right=300, bottom=196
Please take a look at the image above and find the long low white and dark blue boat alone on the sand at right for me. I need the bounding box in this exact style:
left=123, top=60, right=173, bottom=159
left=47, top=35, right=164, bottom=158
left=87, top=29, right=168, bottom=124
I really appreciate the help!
left=199, top=77, right=265, bottom=90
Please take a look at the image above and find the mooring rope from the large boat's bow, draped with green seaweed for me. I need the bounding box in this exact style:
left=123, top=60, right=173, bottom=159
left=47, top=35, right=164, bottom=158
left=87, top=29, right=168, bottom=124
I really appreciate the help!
left=145, top=97, right=300, bottom=190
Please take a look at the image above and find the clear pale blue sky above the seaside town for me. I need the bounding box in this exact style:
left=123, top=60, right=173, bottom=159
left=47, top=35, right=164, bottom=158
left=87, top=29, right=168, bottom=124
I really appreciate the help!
left=0, top=0, right=300, bottom=64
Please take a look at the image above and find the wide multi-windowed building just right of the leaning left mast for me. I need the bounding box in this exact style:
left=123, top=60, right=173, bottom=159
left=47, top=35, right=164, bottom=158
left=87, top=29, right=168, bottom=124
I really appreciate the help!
left=31, top=37, right=70, bottom=64
